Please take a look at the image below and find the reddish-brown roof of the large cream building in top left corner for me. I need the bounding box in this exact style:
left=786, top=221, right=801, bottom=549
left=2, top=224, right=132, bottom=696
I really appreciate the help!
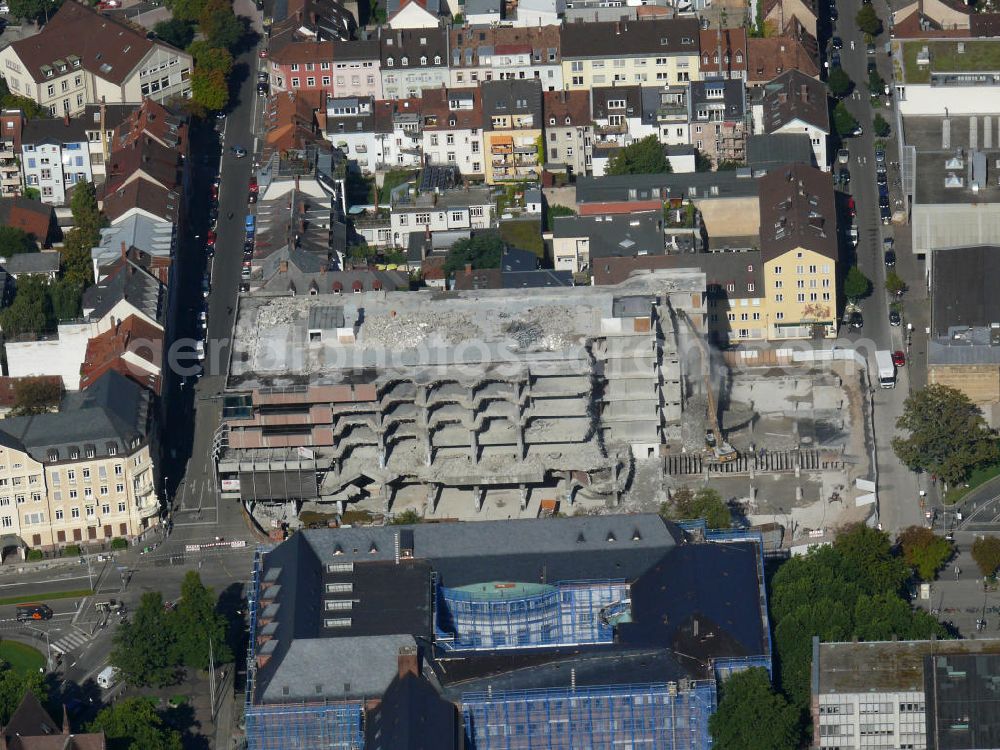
left=11, top=2, right=161, bottom=85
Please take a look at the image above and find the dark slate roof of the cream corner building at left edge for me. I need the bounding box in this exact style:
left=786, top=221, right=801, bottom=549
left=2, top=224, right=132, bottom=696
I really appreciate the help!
left=0, top=370, right=150, bottom=462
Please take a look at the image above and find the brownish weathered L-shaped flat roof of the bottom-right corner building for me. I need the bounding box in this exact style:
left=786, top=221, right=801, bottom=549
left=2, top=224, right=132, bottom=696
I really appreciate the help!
left=813, top=638, right=1000, bottom=695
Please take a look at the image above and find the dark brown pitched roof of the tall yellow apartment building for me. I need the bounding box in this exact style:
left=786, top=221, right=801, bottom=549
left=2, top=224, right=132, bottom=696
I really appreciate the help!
left=759, top=164, right=839, bottom=263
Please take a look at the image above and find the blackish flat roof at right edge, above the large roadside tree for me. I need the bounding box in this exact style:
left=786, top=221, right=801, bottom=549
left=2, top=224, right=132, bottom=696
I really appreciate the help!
left=931, top=245, right=1000, bottom=336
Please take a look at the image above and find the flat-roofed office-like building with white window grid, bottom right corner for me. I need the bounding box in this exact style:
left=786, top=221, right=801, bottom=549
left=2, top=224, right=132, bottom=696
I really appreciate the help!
left=810, top=638, right=1000, bottom=750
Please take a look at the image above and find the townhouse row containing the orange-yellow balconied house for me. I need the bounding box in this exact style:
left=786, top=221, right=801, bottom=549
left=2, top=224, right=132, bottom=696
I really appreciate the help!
left=322, top=71, right=830, bottom=184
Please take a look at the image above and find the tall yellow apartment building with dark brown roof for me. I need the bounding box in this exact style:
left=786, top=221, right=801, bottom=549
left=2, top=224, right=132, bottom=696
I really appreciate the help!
left=758, top=164, right=840, bottom=340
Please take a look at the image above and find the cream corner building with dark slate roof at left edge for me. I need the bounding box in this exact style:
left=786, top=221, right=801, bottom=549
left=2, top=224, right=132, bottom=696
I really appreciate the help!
left=0, top=371, right=160, bottom=549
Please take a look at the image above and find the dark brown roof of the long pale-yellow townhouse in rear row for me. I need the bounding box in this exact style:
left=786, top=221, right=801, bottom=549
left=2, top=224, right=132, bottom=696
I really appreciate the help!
left=562, top=18, right=699, bottom=59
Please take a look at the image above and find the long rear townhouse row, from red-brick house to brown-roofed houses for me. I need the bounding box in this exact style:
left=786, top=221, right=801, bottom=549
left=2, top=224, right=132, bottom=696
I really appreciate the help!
left=268, top=15, right=819, bottom=99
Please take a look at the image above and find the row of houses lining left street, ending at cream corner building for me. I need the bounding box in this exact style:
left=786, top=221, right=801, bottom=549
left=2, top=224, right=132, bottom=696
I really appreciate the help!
left=0, top=99, right=190, bottom=551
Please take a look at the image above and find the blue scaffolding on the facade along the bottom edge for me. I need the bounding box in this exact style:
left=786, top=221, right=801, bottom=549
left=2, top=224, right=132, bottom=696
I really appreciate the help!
left=462, top=680, right=716, bottom=750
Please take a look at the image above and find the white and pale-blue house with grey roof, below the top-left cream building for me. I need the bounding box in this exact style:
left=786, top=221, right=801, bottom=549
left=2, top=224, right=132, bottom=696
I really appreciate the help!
left=21, top=115, right=93, bottom=206
